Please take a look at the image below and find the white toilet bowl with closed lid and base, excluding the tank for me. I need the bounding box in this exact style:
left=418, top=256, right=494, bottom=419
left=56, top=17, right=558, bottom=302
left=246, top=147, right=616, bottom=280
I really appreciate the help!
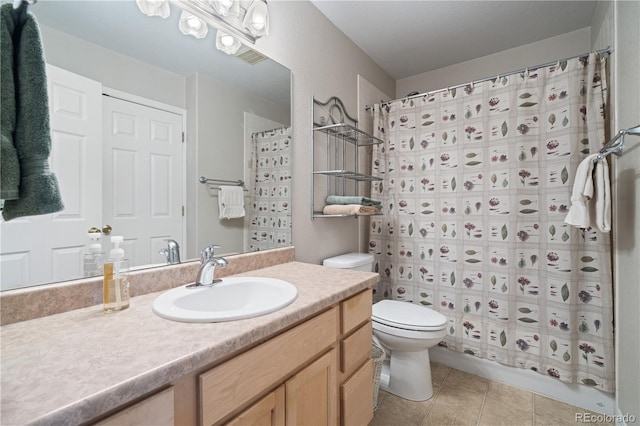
left=371, top=300, right=447, bottom=401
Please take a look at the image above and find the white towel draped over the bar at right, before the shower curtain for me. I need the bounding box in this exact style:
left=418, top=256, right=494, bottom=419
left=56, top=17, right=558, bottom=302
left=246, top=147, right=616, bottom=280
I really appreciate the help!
left=564, top=154, right=611, bottom=232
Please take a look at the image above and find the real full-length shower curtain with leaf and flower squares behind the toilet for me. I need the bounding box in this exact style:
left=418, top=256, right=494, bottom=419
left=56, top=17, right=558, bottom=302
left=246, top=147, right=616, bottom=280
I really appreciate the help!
left=370, top=54, right=614, bottom=392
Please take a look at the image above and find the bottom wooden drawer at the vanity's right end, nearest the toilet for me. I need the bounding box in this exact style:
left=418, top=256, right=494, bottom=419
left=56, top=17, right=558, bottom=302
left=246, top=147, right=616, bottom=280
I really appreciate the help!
left=340, top=360, right=373, bottom=426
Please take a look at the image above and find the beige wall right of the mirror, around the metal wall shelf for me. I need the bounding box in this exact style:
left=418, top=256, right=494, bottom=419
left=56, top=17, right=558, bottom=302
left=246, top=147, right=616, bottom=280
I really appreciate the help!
left=255, top=1, right=395, bottom=263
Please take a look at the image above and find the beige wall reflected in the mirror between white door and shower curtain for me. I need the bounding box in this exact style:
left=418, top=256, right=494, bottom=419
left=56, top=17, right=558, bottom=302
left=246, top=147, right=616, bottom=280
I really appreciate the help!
left=186, top=74, right=290, bottom=259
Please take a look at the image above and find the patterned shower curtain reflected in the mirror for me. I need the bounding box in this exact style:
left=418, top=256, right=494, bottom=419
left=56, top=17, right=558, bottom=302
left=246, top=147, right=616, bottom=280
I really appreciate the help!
left=249, top=127, right=291, bottom=251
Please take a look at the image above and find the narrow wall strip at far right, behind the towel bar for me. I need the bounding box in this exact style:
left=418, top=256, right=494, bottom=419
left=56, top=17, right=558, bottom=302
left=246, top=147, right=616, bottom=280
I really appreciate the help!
left=609, top=1, right=640, bottom=421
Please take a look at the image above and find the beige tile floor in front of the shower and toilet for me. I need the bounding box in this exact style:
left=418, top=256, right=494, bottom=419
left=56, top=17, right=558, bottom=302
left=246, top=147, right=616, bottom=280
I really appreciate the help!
left=369, top=362, right=613, bottom=426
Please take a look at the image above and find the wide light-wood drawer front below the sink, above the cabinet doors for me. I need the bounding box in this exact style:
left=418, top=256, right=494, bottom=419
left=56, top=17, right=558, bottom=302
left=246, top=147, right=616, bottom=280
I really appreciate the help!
left=199, top=307, right=338, bottom=425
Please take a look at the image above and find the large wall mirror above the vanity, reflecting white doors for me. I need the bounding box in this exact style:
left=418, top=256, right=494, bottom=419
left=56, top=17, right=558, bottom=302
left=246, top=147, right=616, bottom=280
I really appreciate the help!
left=0, top=0, right=293, bottom=290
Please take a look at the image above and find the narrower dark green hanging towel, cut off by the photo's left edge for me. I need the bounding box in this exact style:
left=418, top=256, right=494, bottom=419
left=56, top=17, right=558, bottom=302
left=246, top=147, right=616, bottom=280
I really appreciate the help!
left=0, top=3, right=20, bottom=200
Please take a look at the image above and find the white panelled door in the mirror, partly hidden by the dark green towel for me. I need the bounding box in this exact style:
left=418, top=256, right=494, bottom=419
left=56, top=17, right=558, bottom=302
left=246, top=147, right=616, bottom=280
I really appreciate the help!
left=0, top=65, right=102, bottom=290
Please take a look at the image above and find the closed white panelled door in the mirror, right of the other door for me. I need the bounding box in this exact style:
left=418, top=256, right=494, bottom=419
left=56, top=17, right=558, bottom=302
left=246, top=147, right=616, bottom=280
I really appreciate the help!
left=103, top=96, right=184, bottom=266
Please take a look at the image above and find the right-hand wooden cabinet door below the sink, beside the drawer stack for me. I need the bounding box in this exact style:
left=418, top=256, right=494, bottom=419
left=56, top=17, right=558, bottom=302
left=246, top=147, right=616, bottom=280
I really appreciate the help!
left=285, top=349, right=338, bottom=426
